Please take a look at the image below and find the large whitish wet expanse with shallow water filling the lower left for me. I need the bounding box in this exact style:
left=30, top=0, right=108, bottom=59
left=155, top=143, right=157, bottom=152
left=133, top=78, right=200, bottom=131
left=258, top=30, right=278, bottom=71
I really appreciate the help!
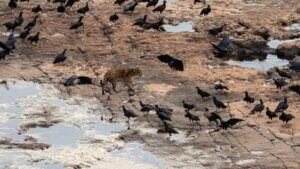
left=0, top=81, right=164, bottom=169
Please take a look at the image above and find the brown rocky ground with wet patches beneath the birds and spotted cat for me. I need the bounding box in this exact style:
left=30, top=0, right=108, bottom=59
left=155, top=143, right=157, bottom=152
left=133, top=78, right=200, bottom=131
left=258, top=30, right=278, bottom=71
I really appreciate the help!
left=0, top=0, right=300, bottom=169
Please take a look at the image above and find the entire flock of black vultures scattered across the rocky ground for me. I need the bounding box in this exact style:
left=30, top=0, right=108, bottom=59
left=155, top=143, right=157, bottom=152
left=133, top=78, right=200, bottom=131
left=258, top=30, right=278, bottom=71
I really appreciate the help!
left=0, top=0, right=300, bottom=139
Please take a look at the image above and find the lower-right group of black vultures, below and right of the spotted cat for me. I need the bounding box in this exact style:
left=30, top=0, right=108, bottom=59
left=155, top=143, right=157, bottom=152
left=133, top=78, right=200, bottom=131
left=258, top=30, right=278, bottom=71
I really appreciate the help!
left=122, top=77, right=295, bottom=136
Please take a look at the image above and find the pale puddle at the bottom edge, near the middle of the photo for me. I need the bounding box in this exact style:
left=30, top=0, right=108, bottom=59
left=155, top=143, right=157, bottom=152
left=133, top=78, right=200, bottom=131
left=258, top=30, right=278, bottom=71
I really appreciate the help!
left=111, top=143, right=165, bottom=169
